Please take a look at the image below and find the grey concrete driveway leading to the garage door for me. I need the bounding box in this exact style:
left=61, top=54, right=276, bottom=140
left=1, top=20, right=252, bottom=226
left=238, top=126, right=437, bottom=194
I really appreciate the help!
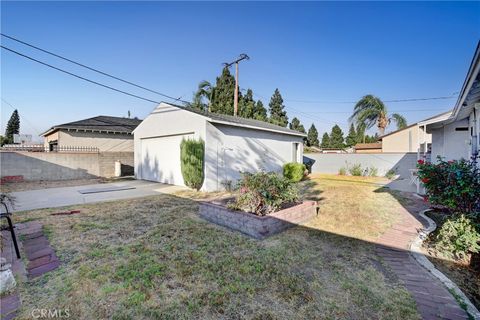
left=11, top=180, right=184, bottom=211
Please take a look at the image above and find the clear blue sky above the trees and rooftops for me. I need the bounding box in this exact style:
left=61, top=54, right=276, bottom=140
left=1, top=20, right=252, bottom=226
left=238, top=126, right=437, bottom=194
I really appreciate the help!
left=0, top=2, right=480, bottom=140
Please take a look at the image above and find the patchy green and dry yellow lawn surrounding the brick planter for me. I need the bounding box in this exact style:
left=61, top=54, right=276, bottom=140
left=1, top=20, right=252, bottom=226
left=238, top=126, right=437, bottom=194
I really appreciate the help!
left=11, top=176, right=419, bottom=319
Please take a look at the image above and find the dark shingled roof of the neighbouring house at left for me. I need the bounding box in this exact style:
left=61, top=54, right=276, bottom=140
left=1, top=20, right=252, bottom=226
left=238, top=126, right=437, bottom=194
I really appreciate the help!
left=41, top=116, right=142, bottom=136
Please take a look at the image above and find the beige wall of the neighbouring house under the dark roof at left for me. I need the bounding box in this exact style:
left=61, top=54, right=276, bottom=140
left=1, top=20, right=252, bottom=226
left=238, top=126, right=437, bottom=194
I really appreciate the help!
left=50, top=130, right=133, bottom=152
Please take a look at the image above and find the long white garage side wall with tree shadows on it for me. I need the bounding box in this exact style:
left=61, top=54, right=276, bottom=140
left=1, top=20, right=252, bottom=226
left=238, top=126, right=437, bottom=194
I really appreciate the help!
left=203, top=123, right=303, bottom=191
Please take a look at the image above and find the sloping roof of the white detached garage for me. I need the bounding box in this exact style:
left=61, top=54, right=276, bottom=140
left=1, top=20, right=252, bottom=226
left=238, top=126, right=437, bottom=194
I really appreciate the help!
left=144, top=102, right=307, bottom=137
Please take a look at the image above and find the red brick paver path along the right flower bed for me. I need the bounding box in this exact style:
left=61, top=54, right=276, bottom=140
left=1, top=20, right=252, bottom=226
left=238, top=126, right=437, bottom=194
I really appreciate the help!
left=376, top=199, right=468, bottom=320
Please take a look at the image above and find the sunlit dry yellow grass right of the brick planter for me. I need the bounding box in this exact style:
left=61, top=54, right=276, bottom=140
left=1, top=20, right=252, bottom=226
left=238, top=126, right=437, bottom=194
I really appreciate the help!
left=300, top=174, right=408, bottom=241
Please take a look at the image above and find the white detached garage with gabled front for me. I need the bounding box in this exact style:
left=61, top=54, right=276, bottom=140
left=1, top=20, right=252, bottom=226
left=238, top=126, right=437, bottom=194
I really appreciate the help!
left=134, top=103, right=306, bottom=191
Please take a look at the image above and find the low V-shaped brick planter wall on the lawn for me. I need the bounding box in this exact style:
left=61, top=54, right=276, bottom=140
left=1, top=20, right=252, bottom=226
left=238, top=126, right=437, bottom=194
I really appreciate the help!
left=199, top=201, right=317, bottom=239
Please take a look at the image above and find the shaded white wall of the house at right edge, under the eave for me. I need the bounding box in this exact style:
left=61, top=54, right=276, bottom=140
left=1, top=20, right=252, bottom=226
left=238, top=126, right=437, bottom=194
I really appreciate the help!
left=432, top=119, right=470, bottom=161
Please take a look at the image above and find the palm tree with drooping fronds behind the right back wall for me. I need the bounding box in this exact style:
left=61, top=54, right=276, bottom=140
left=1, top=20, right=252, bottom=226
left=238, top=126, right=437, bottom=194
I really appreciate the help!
left=350, top=94, right=407, bottom=136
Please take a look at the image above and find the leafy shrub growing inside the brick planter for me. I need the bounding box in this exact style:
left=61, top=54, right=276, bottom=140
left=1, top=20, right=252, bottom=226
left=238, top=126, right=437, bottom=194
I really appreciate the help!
left=228, top=172, right=298, bottom=216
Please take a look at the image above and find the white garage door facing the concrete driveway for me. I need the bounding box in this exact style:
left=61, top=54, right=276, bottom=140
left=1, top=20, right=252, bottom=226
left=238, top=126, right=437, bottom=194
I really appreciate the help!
left=141, top=134, right=193, bottom=186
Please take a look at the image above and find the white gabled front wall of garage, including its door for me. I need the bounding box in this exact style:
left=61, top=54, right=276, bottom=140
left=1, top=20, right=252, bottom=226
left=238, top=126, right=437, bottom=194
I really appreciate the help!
left=134, top=103, right=206, bottom=184
